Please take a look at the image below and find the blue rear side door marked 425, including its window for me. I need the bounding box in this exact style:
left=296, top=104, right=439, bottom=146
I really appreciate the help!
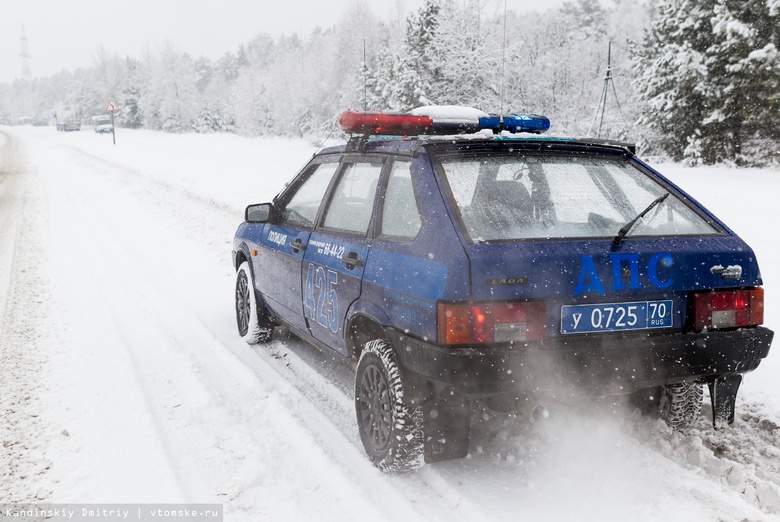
left=303, top=158, right=384, bottom=355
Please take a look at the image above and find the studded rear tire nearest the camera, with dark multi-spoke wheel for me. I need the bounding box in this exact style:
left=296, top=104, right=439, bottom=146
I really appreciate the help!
left=355, top=340, right=425, bottom=471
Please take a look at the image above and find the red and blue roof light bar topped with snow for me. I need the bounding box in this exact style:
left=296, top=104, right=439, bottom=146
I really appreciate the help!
left=339, top=105, right=550, bottom=136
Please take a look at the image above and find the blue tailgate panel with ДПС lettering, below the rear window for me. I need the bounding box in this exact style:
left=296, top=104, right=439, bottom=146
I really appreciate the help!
left=465, top=237, right=762, bottom=335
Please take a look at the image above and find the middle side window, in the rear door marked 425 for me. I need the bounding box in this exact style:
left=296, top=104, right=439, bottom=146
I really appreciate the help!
left=322, top=162, right=382, bottom=236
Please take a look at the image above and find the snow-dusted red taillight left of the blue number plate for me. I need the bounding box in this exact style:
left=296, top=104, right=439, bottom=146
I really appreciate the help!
left=438, top=301, right=547, bottom=344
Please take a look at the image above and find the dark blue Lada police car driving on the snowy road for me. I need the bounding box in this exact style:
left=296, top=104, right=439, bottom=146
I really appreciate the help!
left=233, top=107, right=773, bottom=470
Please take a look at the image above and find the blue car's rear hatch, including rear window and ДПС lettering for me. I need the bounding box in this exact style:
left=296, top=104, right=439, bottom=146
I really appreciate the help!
left=435, top=142, right=761, bottom=342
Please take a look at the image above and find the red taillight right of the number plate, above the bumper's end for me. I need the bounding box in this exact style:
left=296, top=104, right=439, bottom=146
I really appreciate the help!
left=693, top=288, right=764, bottom=330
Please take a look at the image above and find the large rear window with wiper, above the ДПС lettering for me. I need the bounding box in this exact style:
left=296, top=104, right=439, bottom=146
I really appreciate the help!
left=438, top=154, right=719, bottom=242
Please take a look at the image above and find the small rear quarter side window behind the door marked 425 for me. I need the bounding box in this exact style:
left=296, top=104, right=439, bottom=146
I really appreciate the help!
left=380, top=161, right=422, bottom=239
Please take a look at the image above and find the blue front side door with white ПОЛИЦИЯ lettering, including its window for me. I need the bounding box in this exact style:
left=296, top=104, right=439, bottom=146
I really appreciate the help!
left=252, top=157, right=339, bottom=331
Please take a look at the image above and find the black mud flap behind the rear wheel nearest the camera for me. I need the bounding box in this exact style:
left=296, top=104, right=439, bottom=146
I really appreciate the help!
left=423, top=401, right=471, bottom=463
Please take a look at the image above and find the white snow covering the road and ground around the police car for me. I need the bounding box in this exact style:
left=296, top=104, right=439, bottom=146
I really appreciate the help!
left=0, top=127, right=780, bottom=521
